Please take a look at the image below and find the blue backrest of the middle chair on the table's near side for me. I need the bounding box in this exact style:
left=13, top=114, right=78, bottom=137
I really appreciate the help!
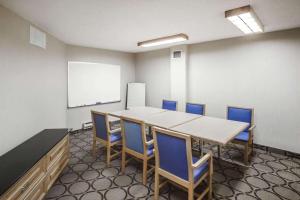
left=123, top=120, right=144, bottom=154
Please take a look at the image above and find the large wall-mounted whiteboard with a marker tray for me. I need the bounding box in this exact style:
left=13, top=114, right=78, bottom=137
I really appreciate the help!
left=68, top=61, right=121, bottom=108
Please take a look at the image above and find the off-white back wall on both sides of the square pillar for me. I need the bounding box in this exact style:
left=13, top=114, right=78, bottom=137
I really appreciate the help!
left=136, top=29, right=300, bottom=153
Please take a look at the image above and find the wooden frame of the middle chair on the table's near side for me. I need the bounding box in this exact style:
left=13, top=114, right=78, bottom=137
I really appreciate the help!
left=121, top=117, right=154, bottom=185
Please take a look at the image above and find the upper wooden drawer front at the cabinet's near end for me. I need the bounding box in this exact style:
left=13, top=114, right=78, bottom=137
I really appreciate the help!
left=4, top=159, right=45, bottom=200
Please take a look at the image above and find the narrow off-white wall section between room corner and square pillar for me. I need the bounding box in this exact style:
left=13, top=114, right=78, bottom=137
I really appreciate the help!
left=135, top=49, right=170, bottom=107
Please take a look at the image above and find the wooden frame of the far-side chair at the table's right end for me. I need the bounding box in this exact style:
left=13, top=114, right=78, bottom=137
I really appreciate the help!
left=219, top=106, right=256, bottom=165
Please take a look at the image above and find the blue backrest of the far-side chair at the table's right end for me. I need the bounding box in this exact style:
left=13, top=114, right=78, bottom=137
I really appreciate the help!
left=227, top=107, right=252, bottom=131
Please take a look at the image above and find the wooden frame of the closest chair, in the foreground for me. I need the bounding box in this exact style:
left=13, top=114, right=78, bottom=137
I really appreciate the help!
left=152, top=127, right=213, bottom=200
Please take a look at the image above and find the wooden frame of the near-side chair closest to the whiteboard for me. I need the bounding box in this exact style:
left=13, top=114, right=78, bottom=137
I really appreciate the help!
left=91, top=110, right=122, bottom=166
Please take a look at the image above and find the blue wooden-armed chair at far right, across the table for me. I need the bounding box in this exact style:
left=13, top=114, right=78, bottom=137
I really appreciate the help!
left=227, top=106, right=255, bottom=164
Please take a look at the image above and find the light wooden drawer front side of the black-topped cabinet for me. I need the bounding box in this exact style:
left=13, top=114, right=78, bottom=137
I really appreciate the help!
left=0, top=135, right=69, bottom=200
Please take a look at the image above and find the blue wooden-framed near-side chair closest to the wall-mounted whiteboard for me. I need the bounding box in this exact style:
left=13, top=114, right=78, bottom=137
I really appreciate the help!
left=91, top=111, right=122, bottom=165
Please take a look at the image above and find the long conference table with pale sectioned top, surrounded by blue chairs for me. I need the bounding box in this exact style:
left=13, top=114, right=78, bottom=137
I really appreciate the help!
left=108, top=107, right=249, bottom=153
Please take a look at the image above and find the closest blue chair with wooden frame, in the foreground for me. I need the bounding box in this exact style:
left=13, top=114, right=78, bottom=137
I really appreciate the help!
left=152, top=127, right=213, bottom=200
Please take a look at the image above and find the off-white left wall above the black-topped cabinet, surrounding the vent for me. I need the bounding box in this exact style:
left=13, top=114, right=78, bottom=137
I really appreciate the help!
left=0, top=6, right=67, bottom=155
